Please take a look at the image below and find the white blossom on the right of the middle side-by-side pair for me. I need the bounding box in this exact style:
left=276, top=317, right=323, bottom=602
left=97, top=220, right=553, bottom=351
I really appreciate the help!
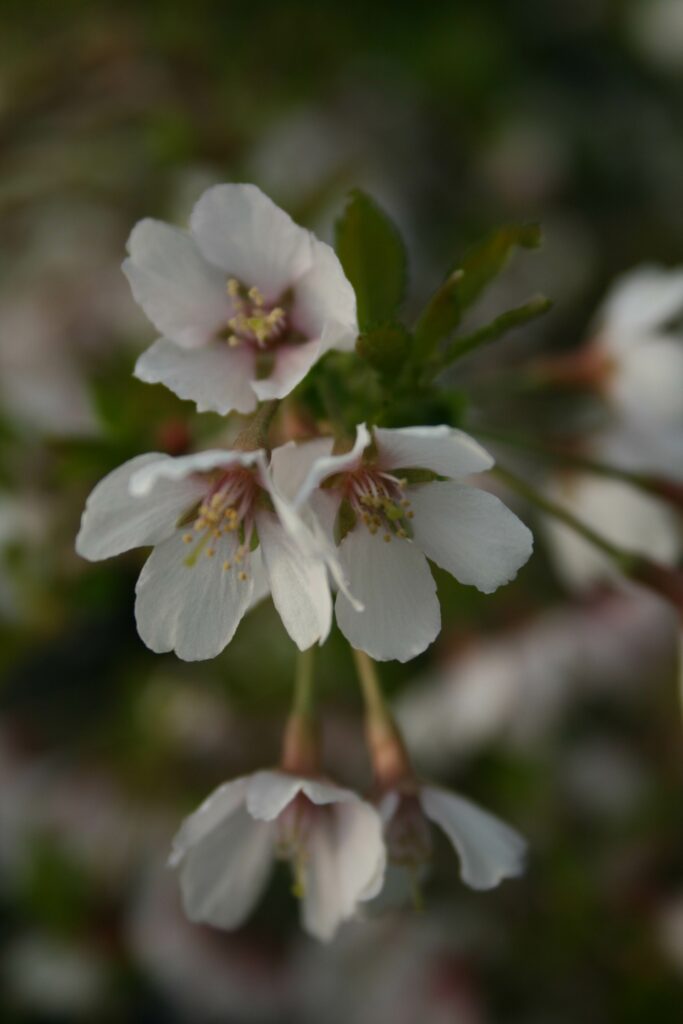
left=272, top=425, right=532, bottom=662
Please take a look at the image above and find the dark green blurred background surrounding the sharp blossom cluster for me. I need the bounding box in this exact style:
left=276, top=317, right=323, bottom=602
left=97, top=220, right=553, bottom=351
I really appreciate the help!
left=0, top=0, right=683, bottom=1024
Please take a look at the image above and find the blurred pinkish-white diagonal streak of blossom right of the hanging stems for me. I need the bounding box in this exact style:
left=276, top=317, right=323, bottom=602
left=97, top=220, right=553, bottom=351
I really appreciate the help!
left=395, top=591, right=676, bottom=771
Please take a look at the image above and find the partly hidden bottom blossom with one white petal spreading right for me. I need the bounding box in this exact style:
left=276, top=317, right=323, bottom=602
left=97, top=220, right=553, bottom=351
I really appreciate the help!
left=379, top=780, right=526, bottom=889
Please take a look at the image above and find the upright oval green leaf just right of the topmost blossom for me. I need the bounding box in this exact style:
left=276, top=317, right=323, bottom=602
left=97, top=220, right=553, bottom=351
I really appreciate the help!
left=336, top=189, right=407, bottom=331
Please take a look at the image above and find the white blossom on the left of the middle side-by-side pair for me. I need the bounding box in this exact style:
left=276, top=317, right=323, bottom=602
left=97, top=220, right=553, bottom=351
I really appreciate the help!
left=76, top=450, right=332, bottom=660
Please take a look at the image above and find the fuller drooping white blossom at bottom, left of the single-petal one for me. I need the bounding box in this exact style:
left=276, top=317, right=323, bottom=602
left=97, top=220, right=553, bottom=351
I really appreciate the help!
left=170, top=771, right=385, bottom=941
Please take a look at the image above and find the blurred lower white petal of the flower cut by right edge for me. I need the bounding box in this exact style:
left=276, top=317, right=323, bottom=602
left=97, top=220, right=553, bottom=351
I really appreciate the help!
left=609, top=335, right=683, bottom=423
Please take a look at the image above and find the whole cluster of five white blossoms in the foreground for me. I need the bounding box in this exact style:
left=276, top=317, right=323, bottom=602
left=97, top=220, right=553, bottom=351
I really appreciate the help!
left=77, top=184, right=532, bottom=939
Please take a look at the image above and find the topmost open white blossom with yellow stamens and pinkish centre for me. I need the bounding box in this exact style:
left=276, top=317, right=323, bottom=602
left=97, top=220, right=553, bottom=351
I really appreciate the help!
left=123, top=184, right=357, bottom=414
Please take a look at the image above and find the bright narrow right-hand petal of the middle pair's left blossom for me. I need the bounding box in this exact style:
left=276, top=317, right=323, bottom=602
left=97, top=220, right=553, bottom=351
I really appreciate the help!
left=256, top=511, right=332, bottom=650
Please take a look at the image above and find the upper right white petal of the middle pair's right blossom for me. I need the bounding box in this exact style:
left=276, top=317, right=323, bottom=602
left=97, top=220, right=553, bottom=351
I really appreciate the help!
left=374, top=427, right=494, bottom=476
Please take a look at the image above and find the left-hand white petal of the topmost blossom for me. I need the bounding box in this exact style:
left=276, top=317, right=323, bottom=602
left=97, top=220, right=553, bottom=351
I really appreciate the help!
left=123, top=218, right=232, bottom=347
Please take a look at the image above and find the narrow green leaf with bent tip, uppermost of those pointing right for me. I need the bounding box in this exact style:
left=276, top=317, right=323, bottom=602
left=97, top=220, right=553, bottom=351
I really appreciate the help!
left=416, top=224, right=541, bottom=352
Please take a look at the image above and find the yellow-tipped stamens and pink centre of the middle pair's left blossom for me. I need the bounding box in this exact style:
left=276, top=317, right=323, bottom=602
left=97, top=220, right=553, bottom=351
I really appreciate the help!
left=182, top=467, right=258, bottom=581
